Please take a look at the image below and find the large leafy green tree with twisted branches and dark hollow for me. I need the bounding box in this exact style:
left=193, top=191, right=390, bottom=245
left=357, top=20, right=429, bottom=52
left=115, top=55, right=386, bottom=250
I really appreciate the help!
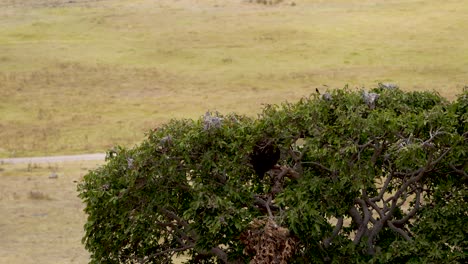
left=78, top=85, right=468, bottom=263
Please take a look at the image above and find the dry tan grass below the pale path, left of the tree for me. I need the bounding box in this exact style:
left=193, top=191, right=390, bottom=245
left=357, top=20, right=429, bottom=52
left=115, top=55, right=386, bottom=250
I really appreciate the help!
left=0, top=161, right=102, bottom=264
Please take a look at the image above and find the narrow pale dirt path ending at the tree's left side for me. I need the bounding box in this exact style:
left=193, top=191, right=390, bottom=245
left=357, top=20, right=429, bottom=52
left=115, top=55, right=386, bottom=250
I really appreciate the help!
left=0, top=153, right=106, bottom=164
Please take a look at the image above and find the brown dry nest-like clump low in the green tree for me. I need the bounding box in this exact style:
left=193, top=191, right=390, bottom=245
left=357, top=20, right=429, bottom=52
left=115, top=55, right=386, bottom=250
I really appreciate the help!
left=241, top=219, right=298, bottom=264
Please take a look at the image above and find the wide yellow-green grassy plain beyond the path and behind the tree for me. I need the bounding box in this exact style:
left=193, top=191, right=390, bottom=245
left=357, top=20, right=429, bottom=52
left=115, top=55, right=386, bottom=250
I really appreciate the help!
left=0, top=0, right=468, bottom=157
